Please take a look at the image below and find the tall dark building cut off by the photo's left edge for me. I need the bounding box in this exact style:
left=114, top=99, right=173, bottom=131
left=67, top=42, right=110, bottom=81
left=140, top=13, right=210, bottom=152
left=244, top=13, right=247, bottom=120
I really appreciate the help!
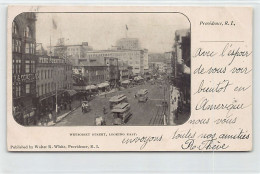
left=12, top=12, right=36, bottom=125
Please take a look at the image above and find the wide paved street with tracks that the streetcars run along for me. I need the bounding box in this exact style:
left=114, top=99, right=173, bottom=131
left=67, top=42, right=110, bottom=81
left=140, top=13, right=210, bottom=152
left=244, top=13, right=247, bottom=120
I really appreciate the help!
left=56, top=83, right=169, bottom=126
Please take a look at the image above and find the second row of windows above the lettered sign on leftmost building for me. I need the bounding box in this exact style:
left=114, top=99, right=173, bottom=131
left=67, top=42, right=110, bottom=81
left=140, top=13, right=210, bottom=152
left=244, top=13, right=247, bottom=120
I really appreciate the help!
left=12, top=39, right=35, bottom=54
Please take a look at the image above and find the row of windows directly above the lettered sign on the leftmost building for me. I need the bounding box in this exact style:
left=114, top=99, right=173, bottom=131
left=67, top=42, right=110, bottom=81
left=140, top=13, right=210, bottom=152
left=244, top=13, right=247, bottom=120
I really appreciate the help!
left=12, top=59, right=35, bottom=74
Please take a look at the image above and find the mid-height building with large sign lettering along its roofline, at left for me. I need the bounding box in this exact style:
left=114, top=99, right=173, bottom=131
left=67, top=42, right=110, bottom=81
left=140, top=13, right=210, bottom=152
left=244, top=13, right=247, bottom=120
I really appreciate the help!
left=36, top=56, right=73, bottom=116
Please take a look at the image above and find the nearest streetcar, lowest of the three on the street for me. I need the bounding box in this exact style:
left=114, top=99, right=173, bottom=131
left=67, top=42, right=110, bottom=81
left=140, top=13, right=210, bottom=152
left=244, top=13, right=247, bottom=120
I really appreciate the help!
left=111, top=103, right=132, bottom=125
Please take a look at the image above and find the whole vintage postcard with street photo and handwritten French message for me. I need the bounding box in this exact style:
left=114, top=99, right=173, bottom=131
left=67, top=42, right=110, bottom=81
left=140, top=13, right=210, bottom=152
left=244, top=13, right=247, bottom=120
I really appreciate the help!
left=7, top=6, right=253, bottom=151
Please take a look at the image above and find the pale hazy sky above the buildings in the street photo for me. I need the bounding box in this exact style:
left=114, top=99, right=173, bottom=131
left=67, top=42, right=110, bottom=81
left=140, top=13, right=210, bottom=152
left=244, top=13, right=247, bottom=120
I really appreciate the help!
left=36, top=13, right=190, bottom=53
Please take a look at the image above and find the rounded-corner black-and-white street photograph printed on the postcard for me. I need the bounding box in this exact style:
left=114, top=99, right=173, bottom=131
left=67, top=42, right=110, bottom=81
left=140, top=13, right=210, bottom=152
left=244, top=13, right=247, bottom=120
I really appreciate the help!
left=12, top=12, right=191, bottom=127
